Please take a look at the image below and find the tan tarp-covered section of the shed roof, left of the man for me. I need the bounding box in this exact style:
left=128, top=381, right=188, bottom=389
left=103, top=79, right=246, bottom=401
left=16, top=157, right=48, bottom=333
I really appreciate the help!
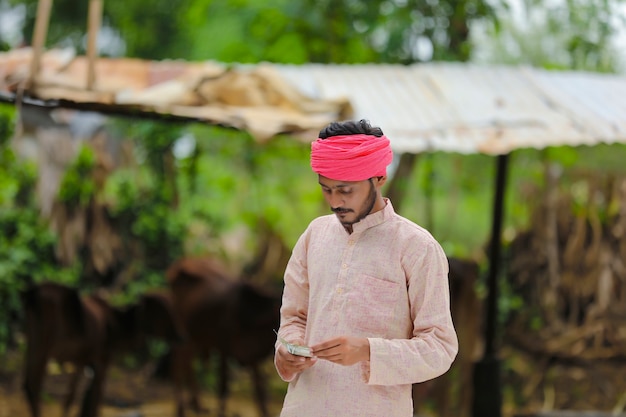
left=0, top=48, right=351, bottom=142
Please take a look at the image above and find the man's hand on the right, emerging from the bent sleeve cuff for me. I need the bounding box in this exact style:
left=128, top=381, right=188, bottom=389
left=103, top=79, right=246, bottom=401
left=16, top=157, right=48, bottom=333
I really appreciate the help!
left=311, top=336, right=370, bottom=366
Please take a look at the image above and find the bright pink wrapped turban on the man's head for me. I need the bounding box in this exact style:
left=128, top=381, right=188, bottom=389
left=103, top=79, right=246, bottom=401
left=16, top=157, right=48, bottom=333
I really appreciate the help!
left=311, top=134, right=393, bottom=181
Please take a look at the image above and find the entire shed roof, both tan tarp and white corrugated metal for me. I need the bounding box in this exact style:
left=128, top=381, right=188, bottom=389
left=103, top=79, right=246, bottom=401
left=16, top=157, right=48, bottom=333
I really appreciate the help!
left=0, top=48, right=626, bottom=155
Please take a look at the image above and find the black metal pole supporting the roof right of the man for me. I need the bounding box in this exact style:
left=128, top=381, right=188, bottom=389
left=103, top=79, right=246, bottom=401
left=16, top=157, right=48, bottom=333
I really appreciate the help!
left=472, top=154, right=509, bottom=417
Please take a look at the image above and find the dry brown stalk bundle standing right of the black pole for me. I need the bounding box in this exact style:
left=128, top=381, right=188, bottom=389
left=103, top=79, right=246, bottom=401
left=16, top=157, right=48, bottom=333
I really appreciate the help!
left=507, top=176, right=626, bottom=361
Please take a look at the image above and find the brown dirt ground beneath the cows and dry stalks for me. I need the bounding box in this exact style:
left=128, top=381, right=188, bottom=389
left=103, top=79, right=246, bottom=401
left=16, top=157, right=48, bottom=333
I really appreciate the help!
left=0, top=348, right=626, bottom=417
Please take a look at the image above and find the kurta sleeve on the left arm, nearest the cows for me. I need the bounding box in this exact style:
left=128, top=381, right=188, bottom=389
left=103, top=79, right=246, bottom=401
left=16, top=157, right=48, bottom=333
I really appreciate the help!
left=275, top=229, right=309, bottom=382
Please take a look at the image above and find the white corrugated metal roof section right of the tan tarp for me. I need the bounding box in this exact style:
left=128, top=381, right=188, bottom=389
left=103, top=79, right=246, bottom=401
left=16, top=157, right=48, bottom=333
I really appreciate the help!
left=274, top=63, right=626, bottom=155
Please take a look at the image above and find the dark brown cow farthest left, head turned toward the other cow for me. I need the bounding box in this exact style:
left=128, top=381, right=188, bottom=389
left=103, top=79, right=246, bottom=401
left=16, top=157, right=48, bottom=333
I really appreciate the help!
left=22, top=282, right=181, bottom=417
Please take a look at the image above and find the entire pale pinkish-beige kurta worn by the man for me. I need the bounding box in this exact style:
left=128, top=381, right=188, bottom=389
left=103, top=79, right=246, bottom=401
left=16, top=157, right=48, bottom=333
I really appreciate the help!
left=279, top=200, right=458, bottom=417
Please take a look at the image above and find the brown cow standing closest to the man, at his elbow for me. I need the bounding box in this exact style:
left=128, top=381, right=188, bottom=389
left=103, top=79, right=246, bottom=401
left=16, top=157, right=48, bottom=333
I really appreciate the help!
left=167, top=258, right=281, bottom=417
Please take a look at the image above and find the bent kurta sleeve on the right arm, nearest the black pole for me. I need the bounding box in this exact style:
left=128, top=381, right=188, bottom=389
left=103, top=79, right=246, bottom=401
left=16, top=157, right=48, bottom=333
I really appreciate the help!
left=362, top=240, right=458, bottom=385
